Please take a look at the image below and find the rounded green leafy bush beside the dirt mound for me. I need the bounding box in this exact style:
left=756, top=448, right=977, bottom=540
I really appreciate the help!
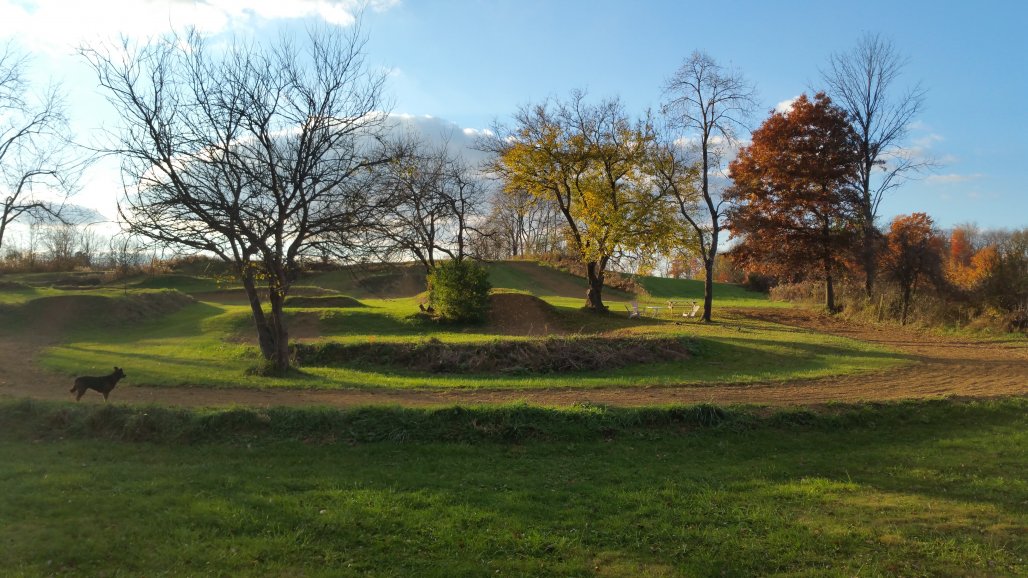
left=429, top=259, right=492, bottom=321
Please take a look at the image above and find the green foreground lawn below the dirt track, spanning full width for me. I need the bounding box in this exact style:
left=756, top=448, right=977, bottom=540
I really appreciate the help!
left=0, top=398, right=1028, bottom=577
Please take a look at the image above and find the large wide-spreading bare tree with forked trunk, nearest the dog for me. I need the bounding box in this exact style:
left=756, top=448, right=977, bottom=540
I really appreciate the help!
left=81, top=28, right=384, bottom=370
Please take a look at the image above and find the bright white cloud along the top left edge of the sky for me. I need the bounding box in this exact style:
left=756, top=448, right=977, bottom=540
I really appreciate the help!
left=0, top=0, right=390, bottom=52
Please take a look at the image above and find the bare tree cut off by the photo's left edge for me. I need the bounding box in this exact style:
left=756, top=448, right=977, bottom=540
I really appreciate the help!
left=0, top=42, right=81, bottom=247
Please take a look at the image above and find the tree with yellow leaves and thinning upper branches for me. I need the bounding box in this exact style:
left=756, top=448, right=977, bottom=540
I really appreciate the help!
left=488, top=92, right=676, bottom=311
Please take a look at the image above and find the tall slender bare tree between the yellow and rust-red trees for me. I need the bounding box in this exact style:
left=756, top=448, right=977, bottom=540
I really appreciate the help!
left=662, top=51, right=757, bottom=321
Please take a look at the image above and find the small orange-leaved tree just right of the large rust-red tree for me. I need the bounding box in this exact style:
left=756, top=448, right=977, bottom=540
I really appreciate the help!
left=883, top=213, right=943, bottom=325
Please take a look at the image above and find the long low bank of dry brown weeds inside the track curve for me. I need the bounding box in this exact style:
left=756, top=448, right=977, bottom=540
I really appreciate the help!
left=294, top=337, right=692, bottom=374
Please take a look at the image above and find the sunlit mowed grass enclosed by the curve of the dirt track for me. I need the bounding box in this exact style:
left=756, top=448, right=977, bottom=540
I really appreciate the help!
left=42, top=299, right=907, bottom=389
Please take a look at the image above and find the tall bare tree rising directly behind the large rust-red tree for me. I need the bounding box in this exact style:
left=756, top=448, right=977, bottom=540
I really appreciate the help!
left=821, top=33, right=933, bottom=296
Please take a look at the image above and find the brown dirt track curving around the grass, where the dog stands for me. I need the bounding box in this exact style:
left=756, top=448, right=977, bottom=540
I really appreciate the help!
left=0, top=310, right=1028, bottom=407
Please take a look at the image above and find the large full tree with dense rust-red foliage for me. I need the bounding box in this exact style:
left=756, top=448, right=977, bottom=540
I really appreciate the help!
left=725, top=93, right=857, bottom=311
